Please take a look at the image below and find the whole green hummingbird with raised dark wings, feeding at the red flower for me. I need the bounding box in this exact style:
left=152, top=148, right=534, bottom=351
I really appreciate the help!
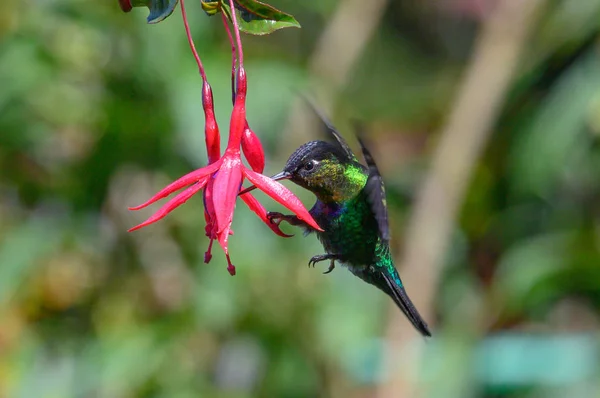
left=240, top=101, right=431, bottom=337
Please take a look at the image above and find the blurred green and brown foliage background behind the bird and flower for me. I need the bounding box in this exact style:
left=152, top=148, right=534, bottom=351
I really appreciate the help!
left=0, top=0, right=600, bottom=398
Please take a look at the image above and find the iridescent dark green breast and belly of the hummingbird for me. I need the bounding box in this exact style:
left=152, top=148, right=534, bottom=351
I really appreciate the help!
left=310, top=192, right=379, bottom=267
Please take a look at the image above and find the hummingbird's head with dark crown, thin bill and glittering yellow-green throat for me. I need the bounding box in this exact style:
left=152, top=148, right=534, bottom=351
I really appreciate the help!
left=271, top=141, right=367, bottom=202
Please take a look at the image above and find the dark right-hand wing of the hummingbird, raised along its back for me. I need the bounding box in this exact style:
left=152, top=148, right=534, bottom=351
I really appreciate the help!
left=357, top=133, right=390, bottom=241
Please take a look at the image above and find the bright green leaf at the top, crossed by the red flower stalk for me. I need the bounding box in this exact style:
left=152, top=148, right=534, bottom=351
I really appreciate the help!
left=202, top=0, right=300, bottom=35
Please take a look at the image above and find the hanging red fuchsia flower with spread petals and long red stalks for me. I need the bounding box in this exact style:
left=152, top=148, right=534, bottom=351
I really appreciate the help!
left=129, top=0, right=321, bottom=275
